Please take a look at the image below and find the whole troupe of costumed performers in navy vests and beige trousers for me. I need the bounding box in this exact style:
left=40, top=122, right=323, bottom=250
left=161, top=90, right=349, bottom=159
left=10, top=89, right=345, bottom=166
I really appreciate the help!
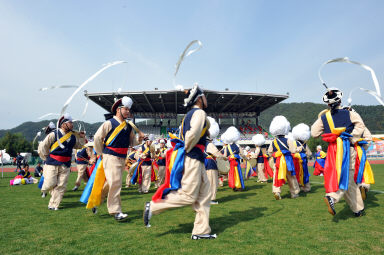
left=24, top=85, right=374, bottom=240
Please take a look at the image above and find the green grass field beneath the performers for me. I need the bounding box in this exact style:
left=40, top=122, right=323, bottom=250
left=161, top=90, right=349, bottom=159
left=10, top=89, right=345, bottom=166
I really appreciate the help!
left=0, top=165, right=384, bottom=255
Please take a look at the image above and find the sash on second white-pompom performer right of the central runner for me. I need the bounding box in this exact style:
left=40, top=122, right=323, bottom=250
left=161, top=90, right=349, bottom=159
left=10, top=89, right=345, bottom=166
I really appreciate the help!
left=227, top=144, right=245, bottom=189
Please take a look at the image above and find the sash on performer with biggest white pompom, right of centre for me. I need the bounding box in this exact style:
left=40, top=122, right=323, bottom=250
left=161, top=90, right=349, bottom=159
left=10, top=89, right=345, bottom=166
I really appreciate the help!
left=273, top=139, right=296, bottom=187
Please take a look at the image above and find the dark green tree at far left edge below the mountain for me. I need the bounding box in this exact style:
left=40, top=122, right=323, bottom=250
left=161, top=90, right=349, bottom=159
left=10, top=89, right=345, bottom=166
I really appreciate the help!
left=0, top=132, right=32, bottom=157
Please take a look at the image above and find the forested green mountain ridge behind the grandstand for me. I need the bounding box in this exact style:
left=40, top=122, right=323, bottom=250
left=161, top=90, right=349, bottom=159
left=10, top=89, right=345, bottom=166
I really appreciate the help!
left=0, top=103, right=384, bottom=141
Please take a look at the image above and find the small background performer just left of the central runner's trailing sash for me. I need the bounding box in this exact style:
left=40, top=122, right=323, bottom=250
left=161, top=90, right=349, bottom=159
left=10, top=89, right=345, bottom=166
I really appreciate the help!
left=137, top=134, right=155, bottom=194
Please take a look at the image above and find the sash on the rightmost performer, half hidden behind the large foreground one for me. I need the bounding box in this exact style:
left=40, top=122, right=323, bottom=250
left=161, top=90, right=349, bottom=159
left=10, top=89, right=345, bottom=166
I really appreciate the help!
left=354, top=139, right=375, bottom=184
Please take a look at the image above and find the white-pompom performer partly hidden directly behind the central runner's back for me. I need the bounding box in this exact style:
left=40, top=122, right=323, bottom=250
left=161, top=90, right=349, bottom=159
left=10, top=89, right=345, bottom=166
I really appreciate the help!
left=205, top=117, right=227, bottom=205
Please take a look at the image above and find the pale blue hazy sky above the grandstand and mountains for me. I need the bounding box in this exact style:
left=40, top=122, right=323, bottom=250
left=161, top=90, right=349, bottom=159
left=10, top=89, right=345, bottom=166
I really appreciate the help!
left=0, top=0, right=384, bottom=129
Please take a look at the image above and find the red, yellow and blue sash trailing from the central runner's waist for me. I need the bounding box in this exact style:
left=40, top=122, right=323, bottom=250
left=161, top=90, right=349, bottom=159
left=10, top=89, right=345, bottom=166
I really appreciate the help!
left=152, top=137, right=185, bottom=202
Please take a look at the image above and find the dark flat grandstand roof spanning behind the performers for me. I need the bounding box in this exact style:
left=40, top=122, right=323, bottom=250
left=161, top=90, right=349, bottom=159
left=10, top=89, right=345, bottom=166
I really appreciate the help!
left=84, top=90, right=288, bottom=118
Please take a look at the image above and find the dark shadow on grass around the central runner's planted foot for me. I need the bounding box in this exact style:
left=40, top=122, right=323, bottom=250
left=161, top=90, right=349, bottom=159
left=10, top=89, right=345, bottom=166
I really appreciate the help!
left=158, top=207, right=267, bottom=236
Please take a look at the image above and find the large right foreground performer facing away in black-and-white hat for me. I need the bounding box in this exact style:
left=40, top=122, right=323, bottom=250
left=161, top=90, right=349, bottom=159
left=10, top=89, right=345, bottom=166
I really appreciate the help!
left=311, top=88, right=365, bottom=217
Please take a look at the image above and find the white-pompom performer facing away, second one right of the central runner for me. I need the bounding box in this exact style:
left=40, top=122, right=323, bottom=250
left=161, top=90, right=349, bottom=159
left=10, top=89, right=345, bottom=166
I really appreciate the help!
left=223, top=126, right=245, bottom=191
